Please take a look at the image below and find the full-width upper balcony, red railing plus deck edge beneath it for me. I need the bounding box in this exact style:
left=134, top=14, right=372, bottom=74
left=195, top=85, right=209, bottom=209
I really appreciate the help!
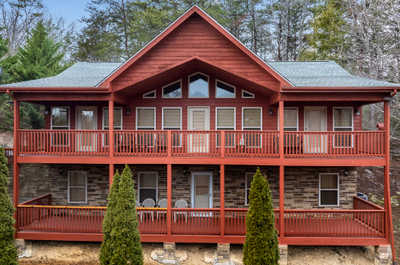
left=17, top=130, right=385, bottom=166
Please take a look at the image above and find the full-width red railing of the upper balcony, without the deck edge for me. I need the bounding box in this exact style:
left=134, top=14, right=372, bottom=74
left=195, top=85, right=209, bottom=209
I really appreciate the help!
left=18, top=130, right=385, bottom=158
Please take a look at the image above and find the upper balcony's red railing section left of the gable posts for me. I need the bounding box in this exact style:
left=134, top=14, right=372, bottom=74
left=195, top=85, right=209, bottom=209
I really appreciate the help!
left=18, top=130, right=109, bottom=156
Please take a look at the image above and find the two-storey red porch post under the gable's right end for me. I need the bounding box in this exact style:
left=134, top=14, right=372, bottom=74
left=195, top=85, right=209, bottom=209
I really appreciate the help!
left=279, top=100, right=285, bottom=238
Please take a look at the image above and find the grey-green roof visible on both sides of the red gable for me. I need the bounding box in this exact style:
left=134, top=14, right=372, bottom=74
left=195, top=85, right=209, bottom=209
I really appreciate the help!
left=0, top=61, right=400, bottom=88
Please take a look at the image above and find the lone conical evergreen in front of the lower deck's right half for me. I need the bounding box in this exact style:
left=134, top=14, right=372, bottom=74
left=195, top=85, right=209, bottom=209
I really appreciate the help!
left=243, top=168, right=279, bottom=265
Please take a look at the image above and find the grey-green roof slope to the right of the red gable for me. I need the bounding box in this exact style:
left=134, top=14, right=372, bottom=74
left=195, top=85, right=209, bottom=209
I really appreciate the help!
left=267, top=61, right=400, bottom=87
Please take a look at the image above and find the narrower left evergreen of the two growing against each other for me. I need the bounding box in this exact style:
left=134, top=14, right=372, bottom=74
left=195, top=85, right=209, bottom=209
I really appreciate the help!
left=100, top=171, right=121, bottom=265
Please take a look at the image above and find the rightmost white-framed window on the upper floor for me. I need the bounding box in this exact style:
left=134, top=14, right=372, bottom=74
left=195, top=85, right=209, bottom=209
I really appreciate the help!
left=333, top=107, right=353, bottom=147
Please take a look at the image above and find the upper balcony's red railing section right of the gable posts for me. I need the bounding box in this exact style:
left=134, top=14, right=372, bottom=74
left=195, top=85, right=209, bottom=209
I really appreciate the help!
left=284, top=131, right=385, bottom=157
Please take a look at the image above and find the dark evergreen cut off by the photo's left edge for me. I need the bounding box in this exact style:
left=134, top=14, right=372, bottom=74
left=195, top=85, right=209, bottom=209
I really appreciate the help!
left=0, top=148, right=18, bottom=265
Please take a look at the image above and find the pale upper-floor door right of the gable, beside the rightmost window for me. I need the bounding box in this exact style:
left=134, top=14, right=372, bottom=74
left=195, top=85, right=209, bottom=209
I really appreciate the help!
left=304, top=107, right=328, bottom=153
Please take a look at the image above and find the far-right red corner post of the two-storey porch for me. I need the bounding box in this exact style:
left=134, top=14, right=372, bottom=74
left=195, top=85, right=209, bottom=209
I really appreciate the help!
left=384, top=101, right=395, bottom=258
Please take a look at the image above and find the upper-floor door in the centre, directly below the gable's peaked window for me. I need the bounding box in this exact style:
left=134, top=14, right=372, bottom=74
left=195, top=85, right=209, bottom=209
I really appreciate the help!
left=188, top=107, right=210, bottom=153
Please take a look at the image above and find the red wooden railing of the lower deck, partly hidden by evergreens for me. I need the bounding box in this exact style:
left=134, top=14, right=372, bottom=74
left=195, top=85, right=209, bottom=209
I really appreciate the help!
left=17, top=205, right=385, bottom=238
